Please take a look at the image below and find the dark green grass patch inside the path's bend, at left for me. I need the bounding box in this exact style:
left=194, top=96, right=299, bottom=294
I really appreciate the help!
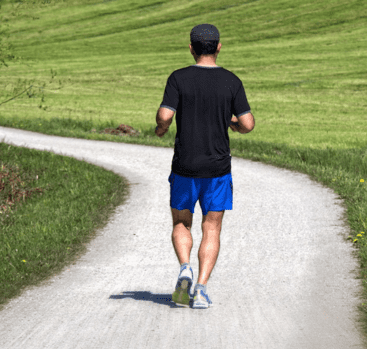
left=0, top=143, right=132, bottom=305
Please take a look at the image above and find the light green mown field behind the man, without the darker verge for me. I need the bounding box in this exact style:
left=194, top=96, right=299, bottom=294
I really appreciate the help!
left=0, top=0, right=367, bottom=148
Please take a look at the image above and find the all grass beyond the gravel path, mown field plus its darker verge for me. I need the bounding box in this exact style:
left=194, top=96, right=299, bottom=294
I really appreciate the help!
left=0, top=0, right=367, bottom=333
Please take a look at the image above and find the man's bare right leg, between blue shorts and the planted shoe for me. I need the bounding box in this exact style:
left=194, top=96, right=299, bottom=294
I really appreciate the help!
left=198, top=210, right=224, bottom=285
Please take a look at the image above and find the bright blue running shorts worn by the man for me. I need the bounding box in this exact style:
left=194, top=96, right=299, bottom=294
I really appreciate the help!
left=168, top=172, right=233, bottom=216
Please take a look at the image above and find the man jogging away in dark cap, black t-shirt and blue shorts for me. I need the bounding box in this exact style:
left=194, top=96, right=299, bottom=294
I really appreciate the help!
left=156, top=24, right=255, bottom=309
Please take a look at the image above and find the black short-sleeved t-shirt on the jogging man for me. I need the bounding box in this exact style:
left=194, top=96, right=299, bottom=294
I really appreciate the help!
left=160, top=65, right=250, bottom=178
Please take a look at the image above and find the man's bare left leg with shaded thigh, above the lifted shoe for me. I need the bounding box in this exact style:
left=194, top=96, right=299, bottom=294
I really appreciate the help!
left=171, top=208, right=192, bottom=264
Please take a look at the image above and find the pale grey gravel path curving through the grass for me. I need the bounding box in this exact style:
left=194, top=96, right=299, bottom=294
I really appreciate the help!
left=0, top=127, right=363, bottom=349
